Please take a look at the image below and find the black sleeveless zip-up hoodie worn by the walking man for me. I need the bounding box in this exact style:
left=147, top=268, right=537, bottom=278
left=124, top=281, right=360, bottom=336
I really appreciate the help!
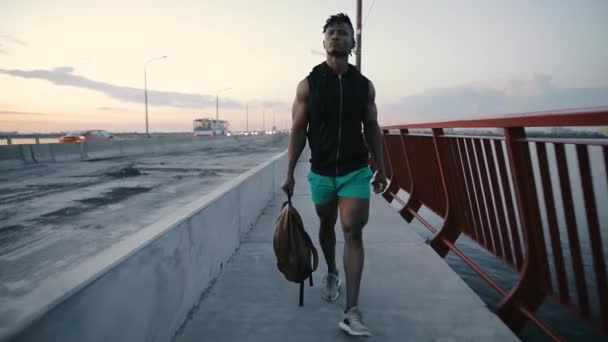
left=307, top=62, right=369, bottom=177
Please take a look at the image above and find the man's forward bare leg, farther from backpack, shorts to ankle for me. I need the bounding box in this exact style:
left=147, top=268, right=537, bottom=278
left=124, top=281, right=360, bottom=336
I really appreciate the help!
left=338, top=197, right=369, bottom=311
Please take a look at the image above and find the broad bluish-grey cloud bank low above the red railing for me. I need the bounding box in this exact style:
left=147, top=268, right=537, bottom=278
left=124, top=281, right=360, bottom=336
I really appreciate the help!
left=382, top=74, right=608, bottom=123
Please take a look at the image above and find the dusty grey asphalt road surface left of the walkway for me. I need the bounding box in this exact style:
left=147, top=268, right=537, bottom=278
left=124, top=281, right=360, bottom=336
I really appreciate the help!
left=0, top=136, right=287, bottom=306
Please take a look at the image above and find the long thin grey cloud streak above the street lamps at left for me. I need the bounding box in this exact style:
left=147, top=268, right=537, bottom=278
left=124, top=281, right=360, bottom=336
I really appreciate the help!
left=0, top=66, right=242, bottom=108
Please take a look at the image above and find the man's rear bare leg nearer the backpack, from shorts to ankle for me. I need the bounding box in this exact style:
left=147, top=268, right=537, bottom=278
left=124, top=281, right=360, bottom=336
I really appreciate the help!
left=315, top=200, right=338, bottom=274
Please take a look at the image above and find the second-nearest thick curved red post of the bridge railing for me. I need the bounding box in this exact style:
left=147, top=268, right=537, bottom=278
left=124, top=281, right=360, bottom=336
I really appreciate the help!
left=429, top=128, right=461, bottom=258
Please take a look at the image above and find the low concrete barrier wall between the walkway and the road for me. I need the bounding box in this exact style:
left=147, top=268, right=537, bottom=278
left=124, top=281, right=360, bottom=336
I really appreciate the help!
left=0, top=153, right=287, bottom=342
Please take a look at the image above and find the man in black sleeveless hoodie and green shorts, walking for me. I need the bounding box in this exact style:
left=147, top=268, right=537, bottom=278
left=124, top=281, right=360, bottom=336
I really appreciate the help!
left=282, top=13, right=386, bottom=335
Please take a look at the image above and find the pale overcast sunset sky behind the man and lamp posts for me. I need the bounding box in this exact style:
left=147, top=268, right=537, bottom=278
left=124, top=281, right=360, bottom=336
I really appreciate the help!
left=0, top=0, right=608, bottom=132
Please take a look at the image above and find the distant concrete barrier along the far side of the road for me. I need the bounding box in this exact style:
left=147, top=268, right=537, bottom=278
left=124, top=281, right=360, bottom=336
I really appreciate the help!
left=0, top=136, right=256, bottom=168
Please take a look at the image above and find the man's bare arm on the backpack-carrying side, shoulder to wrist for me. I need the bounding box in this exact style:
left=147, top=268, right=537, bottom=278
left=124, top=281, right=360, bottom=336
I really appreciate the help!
left=287, top=79, right=308, bottom=177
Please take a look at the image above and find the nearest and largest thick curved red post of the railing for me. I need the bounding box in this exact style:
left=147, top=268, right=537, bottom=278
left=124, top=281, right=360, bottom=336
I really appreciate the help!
left=497, top=127, right=548, bottom=332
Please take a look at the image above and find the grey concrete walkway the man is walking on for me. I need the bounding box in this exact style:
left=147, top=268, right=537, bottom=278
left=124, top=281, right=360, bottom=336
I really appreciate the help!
left=174, top=156, right=517, bottom=342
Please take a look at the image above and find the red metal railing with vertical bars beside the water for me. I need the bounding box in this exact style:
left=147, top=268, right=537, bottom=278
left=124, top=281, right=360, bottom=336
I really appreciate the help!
left=383, top=107, right=608, bottom=340
